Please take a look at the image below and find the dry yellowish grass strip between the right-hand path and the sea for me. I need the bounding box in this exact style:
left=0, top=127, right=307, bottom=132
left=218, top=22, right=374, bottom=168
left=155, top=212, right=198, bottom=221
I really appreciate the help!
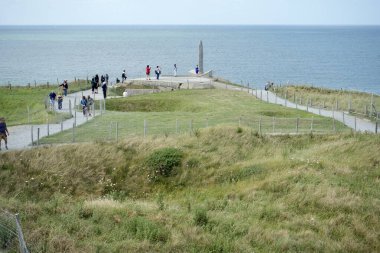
left=272, top=85, right=380, bottom=119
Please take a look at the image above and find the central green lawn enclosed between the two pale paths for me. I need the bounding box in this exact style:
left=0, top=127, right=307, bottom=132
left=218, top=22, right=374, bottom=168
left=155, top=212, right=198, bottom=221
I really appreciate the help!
left=41, top=89, right=349, bottom=143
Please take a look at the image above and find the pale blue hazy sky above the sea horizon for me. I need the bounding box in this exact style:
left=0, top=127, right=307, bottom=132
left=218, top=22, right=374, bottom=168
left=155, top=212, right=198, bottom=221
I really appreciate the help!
left=0, top=0, right=380, bottom=25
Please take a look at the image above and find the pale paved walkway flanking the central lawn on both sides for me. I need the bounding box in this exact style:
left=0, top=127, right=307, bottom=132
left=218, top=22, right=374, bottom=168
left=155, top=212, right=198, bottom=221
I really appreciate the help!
left=3, top=76, right=377, bottom=150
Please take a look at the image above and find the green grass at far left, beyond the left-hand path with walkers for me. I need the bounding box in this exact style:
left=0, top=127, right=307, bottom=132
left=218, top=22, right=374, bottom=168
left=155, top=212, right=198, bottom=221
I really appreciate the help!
left=0, top=80, right=89, bottom=126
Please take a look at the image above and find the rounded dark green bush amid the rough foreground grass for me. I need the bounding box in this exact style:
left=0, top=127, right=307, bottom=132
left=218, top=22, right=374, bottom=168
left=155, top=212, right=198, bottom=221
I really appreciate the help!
left=146, top=148, right=183, bottom=180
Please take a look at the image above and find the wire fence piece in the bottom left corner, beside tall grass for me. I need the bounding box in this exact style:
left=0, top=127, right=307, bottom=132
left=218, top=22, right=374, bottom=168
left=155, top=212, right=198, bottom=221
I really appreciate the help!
left=0, top=209, right=29, bottom=253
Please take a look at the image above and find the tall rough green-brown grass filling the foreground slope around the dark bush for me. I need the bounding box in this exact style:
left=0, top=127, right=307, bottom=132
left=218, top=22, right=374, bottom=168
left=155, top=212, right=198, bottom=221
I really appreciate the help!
left=0, top=129, right=380, bottom=252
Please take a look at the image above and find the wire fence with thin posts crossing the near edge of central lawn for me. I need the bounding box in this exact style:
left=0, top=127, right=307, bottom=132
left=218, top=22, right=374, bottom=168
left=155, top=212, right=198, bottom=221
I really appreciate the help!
left=32, top=117, right=350, bottom=145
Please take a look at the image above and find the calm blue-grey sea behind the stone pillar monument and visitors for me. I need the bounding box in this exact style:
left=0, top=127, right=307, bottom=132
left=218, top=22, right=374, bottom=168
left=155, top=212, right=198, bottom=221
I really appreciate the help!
left=0, top=25, right=380, bottom=94
